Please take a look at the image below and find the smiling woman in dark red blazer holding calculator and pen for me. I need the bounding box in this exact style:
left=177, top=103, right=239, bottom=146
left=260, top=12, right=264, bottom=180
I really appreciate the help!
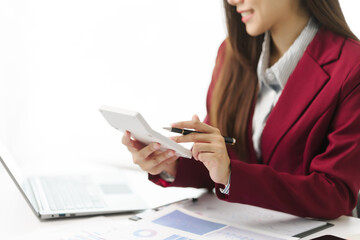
left=123, top=0, right=360, bottom=219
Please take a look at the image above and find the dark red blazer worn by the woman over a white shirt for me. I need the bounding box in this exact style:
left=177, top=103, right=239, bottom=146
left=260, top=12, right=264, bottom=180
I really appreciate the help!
left=149, top=29, right=360, bottom=218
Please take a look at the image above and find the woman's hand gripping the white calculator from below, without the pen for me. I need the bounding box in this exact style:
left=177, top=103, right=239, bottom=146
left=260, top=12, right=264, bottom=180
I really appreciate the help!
left=122, top=131, right=178, bottom=176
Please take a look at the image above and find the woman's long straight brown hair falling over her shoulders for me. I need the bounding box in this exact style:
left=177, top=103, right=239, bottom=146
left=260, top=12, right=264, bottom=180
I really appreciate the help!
left=210, top=0, right=357, bottom=160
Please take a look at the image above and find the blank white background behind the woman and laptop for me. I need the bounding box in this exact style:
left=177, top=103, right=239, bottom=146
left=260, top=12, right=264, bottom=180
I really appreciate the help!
left=0, top=0, right=360, bottom=171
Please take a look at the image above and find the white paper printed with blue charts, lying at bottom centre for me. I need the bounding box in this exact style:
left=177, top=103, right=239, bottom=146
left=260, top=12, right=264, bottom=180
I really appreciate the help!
left=106, top=206, right=297, bottom=240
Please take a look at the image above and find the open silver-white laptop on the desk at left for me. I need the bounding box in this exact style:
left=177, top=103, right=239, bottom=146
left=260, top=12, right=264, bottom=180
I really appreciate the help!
left=0, top=142, right=147, bottom=219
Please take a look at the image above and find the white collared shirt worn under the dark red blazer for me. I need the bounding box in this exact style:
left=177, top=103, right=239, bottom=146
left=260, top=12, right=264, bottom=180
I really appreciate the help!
left=252, top=18, right=319, bottom=159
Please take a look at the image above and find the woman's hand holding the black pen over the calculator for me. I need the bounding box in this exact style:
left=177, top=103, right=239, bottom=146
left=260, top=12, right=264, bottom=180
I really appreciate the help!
left=171, top=115, right=230, bottom=185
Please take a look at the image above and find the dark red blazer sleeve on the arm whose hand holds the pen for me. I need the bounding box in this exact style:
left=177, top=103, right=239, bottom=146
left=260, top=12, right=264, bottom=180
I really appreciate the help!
left=216, top=64, right=360, bottom=219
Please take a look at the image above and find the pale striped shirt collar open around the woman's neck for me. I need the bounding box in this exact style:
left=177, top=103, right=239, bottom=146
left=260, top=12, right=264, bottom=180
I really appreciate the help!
left=257, top=18, right=319, bottom=92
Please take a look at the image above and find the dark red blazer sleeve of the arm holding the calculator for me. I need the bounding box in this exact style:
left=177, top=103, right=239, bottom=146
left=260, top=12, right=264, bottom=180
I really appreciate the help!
left=149, top=41, right=225, bottom=189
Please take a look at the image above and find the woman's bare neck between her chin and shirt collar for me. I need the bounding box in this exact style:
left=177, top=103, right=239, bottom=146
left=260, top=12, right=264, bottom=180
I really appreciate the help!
left=270, top=10, right=310, bottom=66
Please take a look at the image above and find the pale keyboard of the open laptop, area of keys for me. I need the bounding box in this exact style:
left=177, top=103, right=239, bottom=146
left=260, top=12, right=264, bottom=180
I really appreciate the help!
left=40, top=176, right=106, bottom=210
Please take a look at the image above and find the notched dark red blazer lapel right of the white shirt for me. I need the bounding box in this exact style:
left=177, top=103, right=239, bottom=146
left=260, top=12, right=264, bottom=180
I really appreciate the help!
left=261, top=29, right=344, bottom=163
